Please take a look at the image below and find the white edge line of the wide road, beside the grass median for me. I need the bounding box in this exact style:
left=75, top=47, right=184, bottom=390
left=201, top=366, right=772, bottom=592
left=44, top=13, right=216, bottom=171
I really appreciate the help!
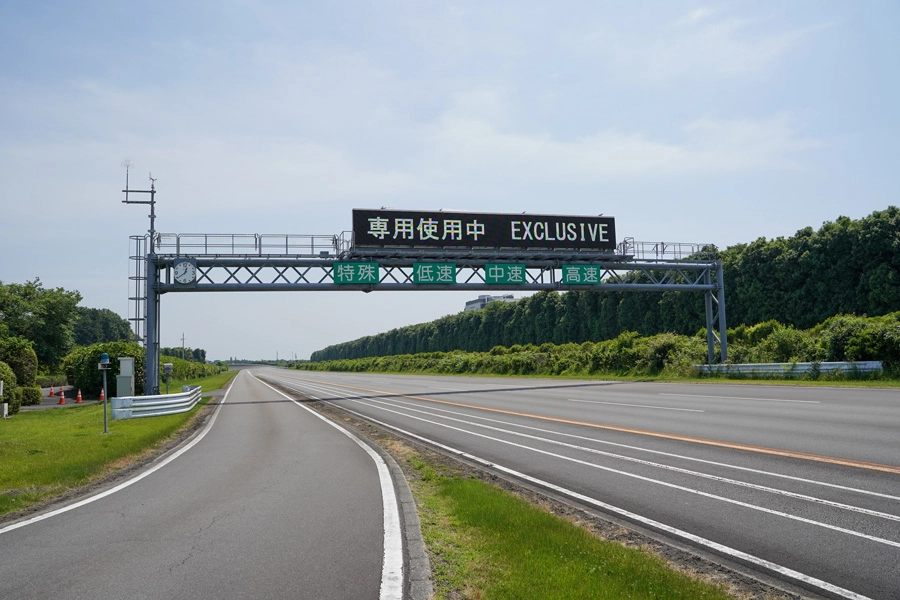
left=326, top=401, right=872, bottom=600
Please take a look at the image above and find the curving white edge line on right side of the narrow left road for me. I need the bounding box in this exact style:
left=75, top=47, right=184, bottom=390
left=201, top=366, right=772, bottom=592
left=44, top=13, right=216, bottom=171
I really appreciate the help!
left=253, top=375, right=403, bottom=600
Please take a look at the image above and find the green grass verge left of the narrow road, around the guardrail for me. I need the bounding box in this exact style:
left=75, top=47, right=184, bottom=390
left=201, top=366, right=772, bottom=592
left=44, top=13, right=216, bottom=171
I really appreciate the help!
left=0, top=371, right=237, bottom=515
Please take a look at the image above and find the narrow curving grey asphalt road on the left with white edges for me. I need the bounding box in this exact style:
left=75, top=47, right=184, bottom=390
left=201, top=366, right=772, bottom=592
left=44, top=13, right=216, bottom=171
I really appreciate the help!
left=0, top=372, right=403, bottom=600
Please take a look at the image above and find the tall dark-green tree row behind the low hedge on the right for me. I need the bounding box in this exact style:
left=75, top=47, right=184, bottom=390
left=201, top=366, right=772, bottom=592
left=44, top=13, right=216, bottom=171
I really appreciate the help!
left=311, top=206, right=900, bottom=361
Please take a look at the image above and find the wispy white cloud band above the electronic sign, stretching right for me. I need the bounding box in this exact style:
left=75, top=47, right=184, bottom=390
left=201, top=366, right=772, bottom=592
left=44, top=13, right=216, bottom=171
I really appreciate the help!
left=433, top=102, right=820, bottom=181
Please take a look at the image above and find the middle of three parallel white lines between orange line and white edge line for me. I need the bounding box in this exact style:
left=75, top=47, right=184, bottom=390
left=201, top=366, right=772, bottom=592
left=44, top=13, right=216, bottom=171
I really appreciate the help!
left=368, top=400, right=900, bottom=521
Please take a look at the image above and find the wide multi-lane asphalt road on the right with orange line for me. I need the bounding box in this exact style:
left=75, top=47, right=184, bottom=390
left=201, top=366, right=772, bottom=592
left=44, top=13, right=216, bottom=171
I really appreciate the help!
left=258, top=368, right=900, bottom=600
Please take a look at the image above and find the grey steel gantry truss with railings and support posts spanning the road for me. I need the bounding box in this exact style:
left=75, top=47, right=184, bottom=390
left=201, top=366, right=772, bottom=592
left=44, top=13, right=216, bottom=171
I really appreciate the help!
left=131, top=232, right=728, bottom=394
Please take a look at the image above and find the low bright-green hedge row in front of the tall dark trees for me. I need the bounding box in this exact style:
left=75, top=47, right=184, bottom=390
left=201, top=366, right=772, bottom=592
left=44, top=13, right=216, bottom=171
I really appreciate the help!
left=293, top=312, right=900, bottom=377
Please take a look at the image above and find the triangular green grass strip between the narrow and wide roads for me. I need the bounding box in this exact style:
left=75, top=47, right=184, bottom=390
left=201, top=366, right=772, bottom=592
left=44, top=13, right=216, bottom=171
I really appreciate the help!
left=409, top=457, right=730, bottom=600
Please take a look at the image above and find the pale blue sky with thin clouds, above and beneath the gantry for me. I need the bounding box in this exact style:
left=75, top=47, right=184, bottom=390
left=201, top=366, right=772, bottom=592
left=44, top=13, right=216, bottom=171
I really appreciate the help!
left=0, top=0, right=900, bottom=358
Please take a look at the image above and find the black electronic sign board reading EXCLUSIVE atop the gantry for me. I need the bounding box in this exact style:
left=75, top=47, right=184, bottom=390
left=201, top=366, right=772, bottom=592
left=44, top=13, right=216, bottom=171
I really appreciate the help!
left=353, top=208, right=616, bottom=252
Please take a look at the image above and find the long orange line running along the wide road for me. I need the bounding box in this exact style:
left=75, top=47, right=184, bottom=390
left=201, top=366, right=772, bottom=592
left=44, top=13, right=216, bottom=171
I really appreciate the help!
left=291, top=377, right=900, bottom=475
